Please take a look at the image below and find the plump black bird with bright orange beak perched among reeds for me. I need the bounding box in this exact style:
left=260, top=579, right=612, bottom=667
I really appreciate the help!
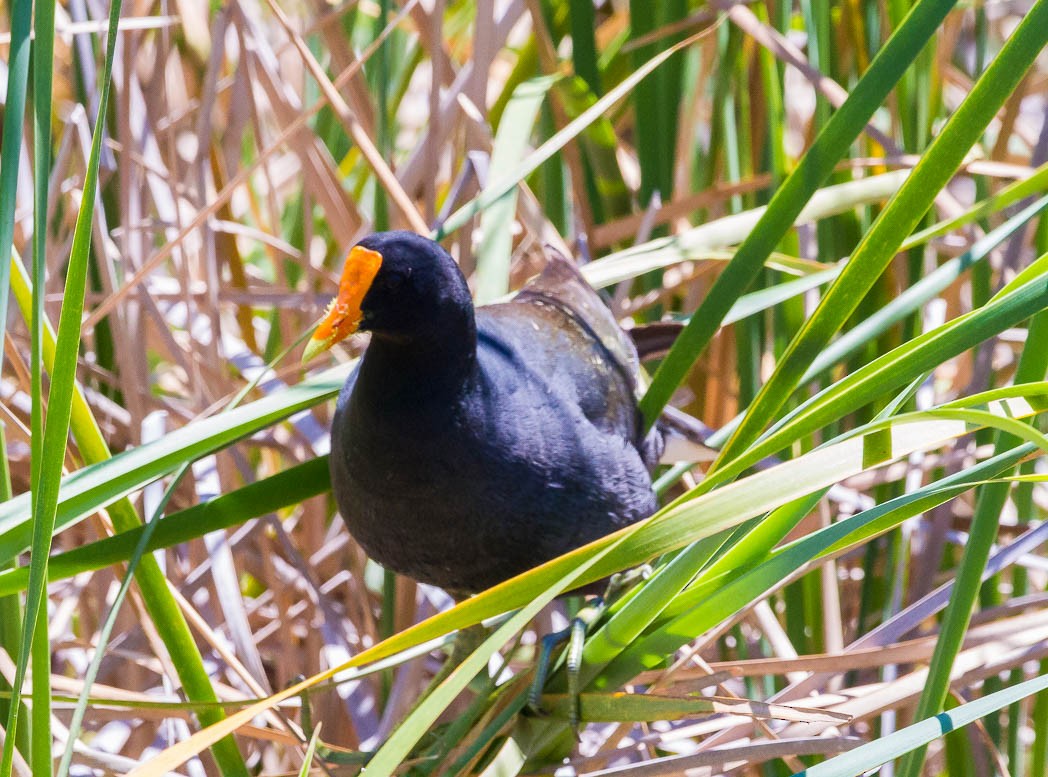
left=305, top=232, right=661, bottom=597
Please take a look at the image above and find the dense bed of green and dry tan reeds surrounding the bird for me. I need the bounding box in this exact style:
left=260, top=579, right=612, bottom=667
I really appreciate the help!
left=0, top=0, right=1048, bottom=777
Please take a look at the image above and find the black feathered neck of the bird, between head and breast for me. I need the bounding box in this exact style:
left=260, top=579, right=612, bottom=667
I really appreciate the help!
left=359, top=310, right=477, bottom=404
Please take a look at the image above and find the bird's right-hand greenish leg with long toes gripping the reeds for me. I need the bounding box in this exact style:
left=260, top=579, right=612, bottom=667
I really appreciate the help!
left=528, top=564, right=652, bottom=739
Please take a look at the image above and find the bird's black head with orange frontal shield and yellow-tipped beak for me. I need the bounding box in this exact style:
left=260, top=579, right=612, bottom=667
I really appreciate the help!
left=302, top=232, right=472, bottom=362
